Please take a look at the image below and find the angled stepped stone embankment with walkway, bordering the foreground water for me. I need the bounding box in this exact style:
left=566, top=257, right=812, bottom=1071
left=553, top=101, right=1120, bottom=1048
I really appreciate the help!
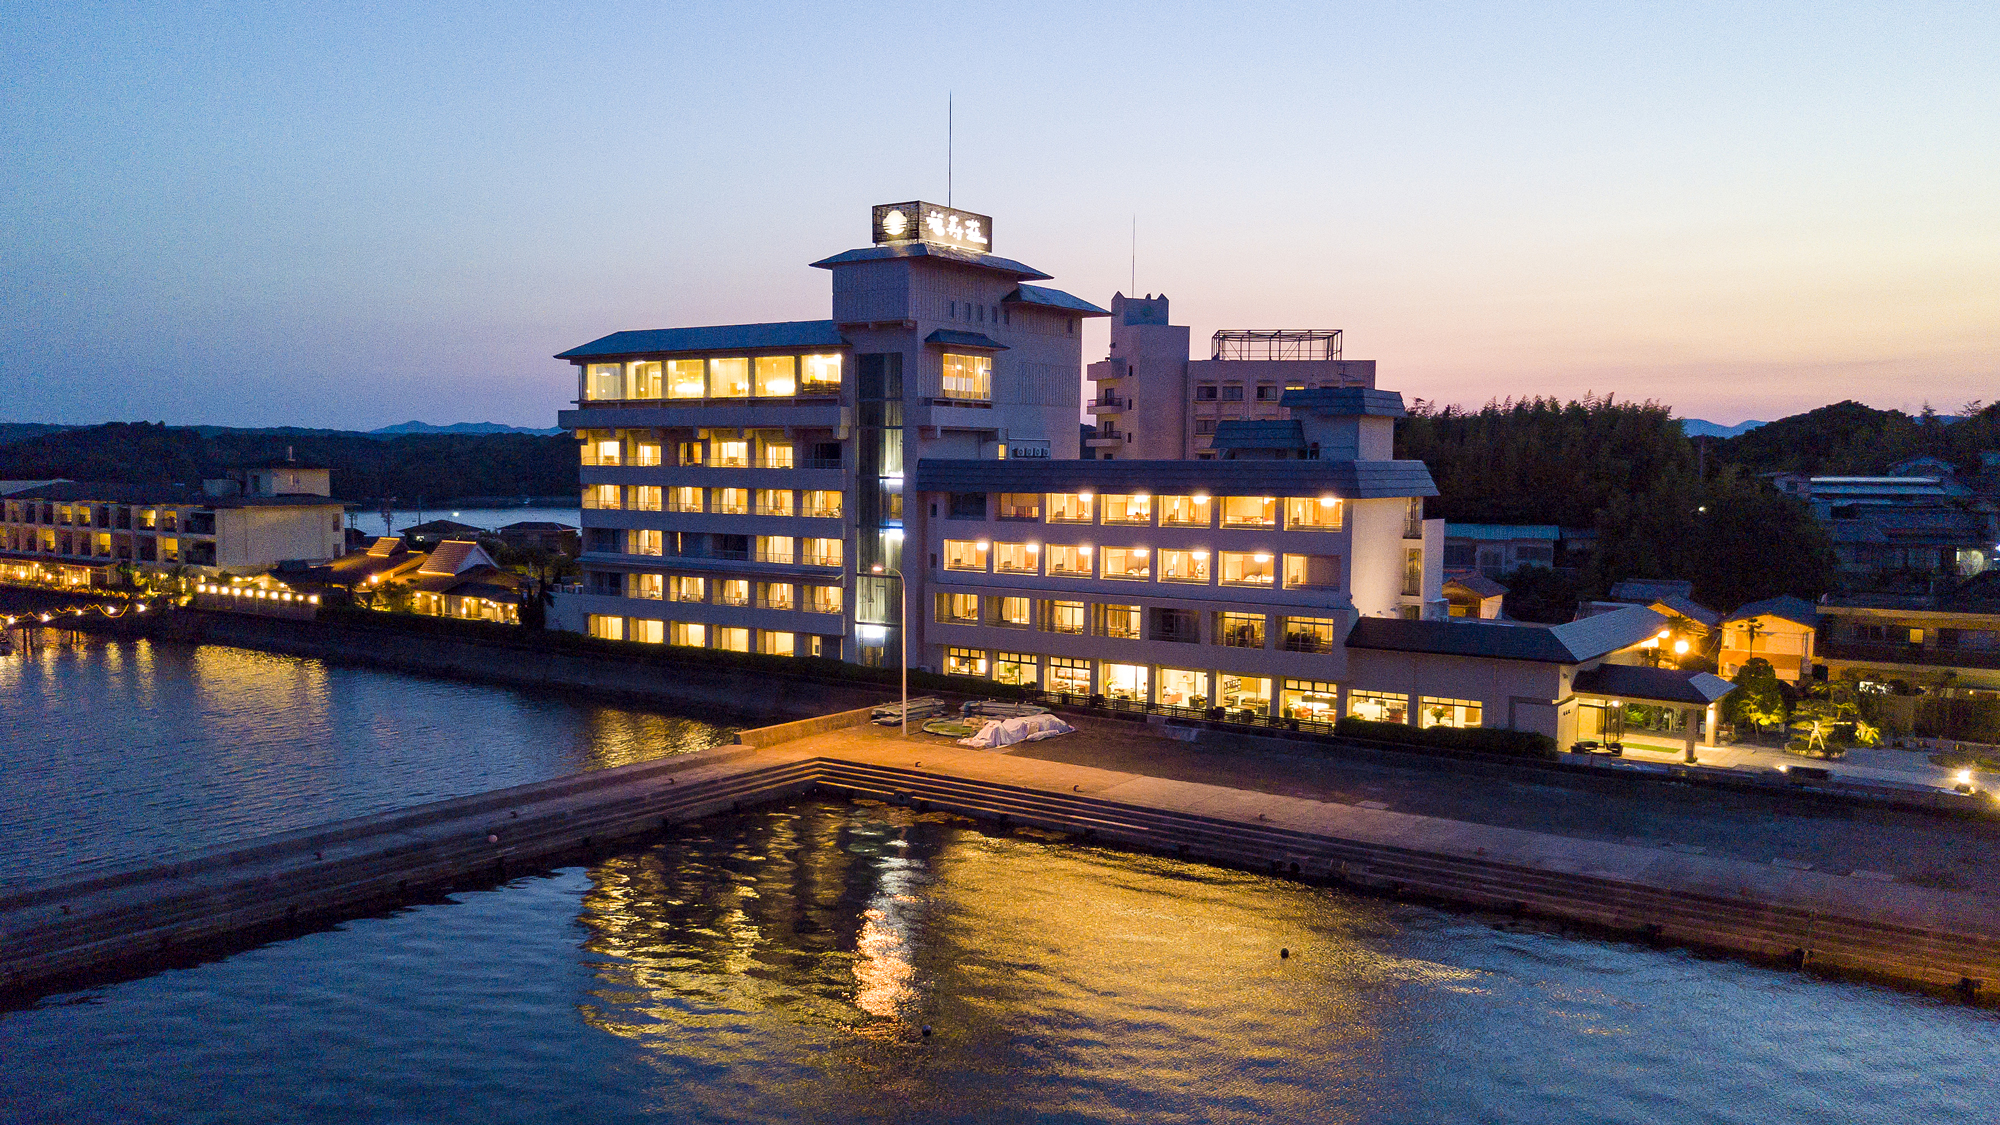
left=0, top=711, right=2000, bottom=999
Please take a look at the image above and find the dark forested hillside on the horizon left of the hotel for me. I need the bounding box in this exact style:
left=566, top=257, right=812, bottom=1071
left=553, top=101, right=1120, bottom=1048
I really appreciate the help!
left=0, top=422, right=576, bottom=500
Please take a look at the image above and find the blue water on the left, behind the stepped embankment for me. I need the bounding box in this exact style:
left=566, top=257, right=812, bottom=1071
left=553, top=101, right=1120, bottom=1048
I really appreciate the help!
left=0, top=633, right=728, bottom=883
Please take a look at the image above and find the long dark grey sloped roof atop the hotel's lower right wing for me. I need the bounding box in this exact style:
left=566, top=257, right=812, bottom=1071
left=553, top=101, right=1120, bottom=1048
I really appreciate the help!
left=916, top=458, right=1438, bottom=500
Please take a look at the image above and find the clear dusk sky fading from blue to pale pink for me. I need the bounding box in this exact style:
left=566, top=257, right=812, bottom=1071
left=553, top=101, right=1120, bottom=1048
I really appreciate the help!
left=0, top=0, right=2000, bottom=428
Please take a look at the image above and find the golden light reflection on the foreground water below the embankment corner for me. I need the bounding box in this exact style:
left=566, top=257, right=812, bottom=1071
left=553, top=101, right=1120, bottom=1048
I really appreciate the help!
left=582, top=803, right=1482, bottom=1121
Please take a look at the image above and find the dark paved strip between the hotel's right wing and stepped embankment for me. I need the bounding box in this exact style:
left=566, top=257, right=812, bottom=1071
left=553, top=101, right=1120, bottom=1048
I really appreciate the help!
left=1008, top=717, right=2000, bottom=897
